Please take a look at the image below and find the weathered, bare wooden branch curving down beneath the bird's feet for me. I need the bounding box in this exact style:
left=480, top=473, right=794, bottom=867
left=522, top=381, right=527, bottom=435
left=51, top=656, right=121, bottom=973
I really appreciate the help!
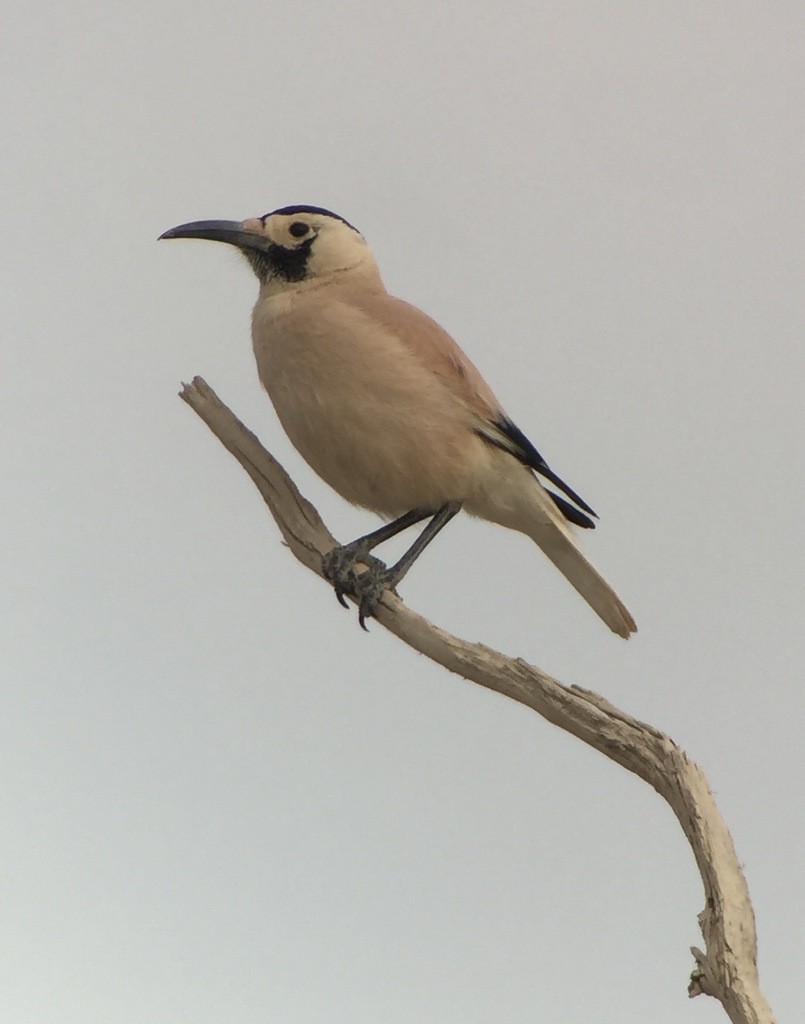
left=181, top=377, right=774, bottom=1024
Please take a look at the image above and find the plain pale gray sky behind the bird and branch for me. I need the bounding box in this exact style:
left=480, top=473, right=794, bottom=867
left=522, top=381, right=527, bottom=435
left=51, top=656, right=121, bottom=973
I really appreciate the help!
left=0, top=0, right=805, bottom=1024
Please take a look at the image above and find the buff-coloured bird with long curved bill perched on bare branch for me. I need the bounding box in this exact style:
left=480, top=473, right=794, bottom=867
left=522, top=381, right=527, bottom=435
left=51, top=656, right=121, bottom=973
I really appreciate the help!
left=160, top=206, right=637, bottom=638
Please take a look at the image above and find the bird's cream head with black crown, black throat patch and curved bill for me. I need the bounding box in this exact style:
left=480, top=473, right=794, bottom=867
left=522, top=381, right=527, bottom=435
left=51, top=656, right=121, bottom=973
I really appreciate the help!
left=160, top=206, right=374, bottom=291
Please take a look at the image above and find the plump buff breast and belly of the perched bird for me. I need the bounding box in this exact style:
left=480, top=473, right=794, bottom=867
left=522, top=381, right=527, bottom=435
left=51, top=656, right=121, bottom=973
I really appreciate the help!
left=253, top=296, right=484, bottom=516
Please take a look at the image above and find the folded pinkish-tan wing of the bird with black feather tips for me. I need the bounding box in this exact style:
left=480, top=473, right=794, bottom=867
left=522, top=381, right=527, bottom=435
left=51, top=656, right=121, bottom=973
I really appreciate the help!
left=350, top=292, right=596, bottom=528
